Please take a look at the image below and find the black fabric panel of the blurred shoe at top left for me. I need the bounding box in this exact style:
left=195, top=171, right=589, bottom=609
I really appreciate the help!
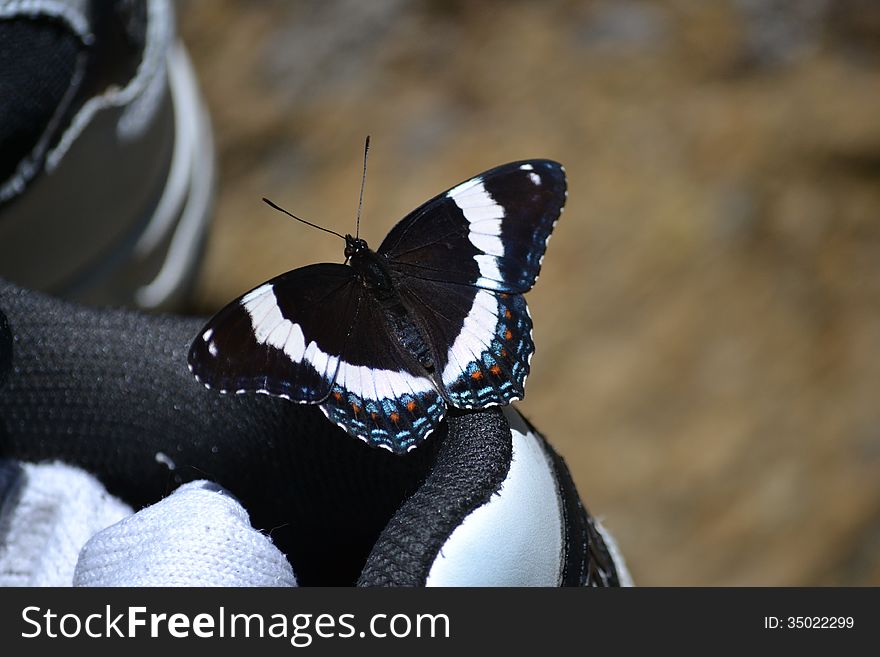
left=0, top=19, right=81, bottom=183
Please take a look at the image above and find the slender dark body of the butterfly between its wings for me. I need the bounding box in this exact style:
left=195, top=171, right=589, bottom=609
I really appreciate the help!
left=345, top=235, right=434, bottom=371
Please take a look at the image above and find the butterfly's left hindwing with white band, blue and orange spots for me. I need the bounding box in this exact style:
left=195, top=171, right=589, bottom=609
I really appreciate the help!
left=321, top=297, right=446, bottom=453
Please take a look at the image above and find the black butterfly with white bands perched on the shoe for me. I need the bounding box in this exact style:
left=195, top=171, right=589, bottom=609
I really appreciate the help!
left=188, top=160, right=567, bottom=454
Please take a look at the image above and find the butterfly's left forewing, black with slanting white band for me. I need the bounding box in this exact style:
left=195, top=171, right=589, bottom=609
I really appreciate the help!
left=189, top=264, right=363, bottom=403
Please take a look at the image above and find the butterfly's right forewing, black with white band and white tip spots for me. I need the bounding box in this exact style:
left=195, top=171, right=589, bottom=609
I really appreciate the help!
left=378, top=160, right=566, bottom=293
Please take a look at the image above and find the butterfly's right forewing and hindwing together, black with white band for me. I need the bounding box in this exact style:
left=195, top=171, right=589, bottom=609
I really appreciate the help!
left=379, top=160, right=566, bottom=408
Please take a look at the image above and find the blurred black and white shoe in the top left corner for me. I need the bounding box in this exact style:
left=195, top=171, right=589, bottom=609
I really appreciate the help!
left=0, top=0, right=215, bottom=310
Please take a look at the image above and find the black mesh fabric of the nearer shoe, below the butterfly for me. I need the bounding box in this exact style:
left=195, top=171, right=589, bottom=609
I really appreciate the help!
left=0, top=282, right=454, bottom=585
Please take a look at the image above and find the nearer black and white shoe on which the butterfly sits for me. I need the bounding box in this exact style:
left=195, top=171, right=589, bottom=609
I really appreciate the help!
left=0, top=281, right=632, bottom=586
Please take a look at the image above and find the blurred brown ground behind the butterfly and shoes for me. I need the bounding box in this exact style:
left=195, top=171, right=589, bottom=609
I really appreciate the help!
left=179, top=0, right=880, bottom=585
